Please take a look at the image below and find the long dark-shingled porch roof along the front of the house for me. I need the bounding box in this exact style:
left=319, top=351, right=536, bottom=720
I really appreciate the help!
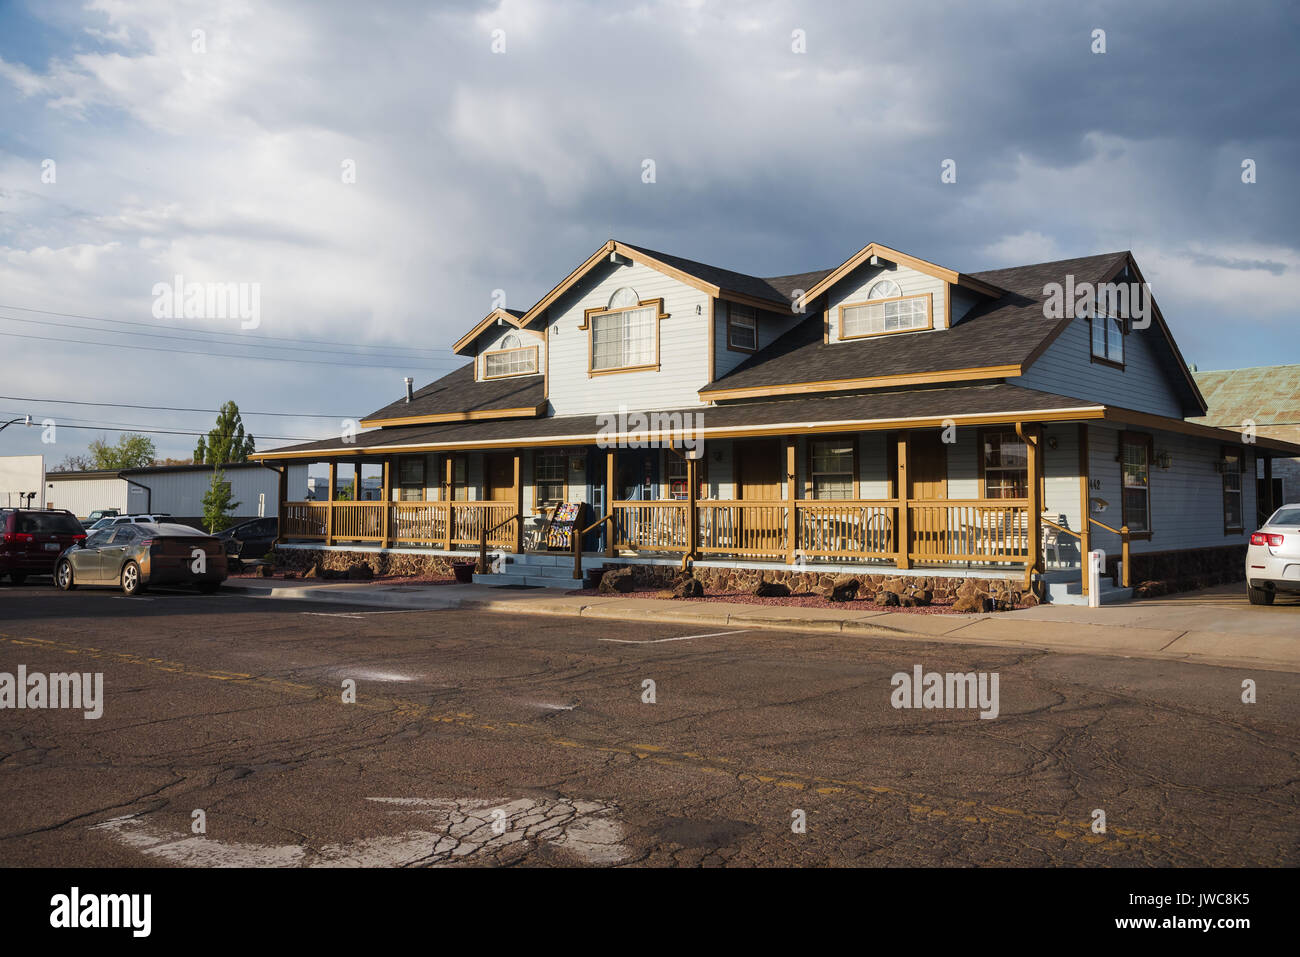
left=255, top=382, right=1105, bottom=459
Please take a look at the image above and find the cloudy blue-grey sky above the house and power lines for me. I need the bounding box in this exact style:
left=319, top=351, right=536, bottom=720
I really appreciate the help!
left=0, top=0, right=1300, bottom=464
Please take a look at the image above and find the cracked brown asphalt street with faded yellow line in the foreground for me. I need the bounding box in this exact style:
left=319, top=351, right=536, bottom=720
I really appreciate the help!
left=0, top=583, right=1300, bottom=867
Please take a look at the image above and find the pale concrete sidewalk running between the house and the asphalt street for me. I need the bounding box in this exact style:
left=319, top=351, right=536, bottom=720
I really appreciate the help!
left=225, top=579, right=1300, bottom=674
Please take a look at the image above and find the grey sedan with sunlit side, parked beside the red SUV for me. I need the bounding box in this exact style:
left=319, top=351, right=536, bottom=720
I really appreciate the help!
left=55, top=521, right=226, bottom=594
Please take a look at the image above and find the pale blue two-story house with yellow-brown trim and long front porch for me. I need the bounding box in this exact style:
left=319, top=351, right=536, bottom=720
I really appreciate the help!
left=256, top=239, right=1300, bottom=601
